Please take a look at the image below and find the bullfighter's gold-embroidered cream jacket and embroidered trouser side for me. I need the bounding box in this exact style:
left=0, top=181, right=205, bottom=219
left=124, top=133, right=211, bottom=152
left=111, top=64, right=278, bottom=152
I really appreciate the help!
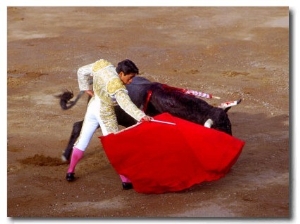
left=77, top=59, right=145, bottom=133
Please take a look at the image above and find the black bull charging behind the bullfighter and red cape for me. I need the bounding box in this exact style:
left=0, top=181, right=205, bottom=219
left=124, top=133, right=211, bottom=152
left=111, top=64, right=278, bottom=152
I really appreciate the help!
left=59, top=76, right=232, bottom=160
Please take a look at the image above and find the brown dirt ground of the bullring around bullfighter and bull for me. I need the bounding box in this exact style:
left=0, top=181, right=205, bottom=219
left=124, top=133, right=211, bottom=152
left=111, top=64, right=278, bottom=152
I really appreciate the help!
left=7, top=7, right=293, bottom=220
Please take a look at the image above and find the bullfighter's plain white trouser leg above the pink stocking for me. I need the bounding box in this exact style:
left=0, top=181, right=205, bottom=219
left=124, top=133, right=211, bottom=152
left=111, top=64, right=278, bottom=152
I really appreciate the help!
left=74, top=96, right=108, bottom=151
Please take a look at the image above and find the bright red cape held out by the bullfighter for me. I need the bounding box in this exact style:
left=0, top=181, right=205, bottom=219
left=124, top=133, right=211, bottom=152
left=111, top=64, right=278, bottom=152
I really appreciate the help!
left=100, top=113, right=245, bottom=193
